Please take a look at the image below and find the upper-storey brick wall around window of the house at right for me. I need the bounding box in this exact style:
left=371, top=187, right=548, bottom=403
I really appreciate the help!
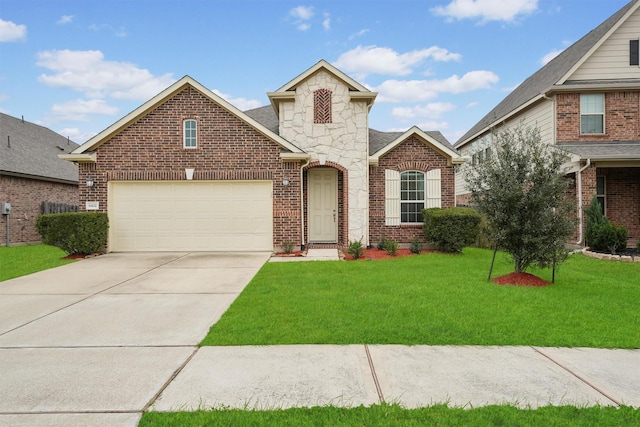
left=556, top=91, right=640, bottom=142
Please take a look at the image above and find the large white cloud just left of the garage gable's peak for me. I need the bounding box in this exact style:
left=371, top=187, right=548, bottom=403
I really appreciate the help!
left=37, top=49, right=175, bottom=101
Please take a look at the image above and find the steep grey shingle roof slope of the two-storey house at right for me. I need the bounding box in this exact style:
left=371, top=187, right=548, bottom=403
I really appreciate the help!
left=454, top=0, right=640, bottom=147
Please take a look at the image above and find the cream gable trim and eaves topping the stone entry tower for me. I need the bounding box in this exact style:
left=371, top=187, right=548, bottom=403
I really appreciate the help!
left=267, top=59, right=378, bottom=115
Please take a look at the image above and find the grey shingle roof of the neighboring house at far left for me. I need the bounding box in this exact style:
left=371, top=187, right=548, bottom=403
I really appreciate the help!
left=0, top=113, right=78, bottom=184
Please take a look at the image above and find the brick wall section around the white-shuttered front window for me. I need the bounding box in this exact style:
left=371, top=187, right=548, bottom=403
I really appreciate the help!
left=369, top=135, right=455, bottom=245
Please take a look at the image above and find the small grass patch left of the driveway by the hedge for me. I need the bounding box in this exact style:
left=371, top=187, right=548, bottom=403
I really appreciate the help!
left=0, top=245, right=73, bottom=282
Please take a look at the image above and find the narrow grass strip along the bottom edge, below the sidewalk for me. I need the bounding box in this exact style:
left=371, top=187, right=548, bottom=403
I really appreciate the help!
left=139, top=405, right=640, bottom=427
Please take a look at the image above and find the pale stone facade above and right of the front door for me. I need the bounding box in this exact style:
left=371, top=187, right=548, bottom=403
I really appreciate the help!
left=279, top=70, right=369, bottom=244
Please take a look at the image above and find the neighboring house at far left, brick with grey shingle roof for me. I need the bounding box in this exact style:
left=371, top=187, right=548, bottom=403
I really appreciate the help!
left=0, top=113, right=78, bottom=245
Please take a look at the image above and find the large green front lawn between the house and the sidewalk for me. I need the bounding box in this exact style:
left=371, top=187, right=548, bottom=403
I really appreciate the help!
left=201, top=248, right=640, bottom=348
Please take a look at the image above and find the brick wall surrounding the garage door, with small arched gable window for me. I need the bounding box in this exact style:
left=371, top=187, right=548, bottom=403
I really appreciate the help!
left=80, top=86, right=302, bottom=246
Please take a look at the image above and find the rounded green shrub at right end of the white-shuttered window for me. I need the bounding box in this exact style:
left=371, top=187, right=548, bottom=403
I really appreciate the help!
left=422, top=207, right=481, bottom=252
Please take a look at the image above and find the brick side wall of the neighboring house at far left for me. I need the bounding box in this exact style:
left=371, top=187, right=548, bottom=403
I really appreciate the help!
left=0, top=175, right=78, bottom=246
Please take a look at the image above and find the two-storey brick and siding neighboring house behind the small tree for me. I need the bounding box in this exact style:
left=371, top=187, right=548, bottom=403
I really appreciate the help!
left=455, top=0, right=640, bottom=247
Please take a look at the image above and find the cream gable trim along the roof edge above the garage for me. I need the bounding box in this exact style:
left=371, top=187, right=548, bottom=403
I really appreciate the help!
left=60, top=76, right=303, bottom=162
